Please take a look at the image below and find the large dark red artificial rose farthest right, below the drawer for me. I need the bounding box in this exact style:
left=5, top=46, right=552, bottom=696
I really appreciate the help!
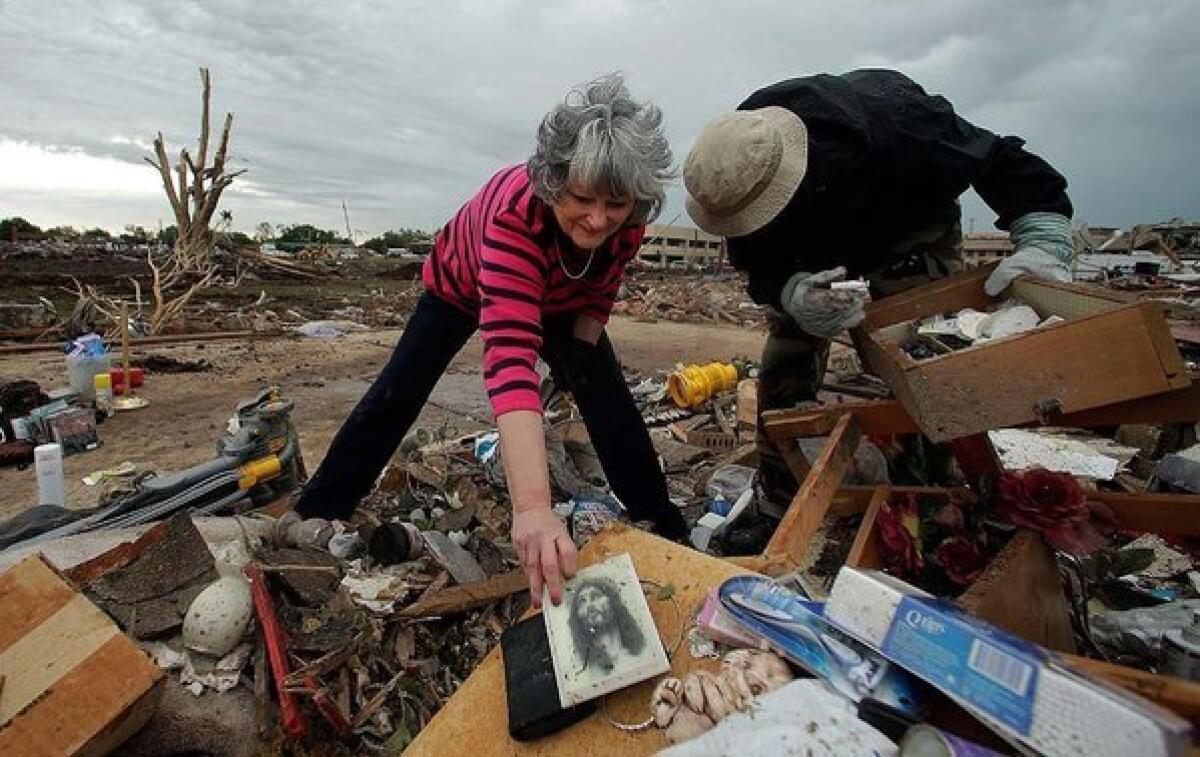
left=996, top=468, right=1091, bottom=531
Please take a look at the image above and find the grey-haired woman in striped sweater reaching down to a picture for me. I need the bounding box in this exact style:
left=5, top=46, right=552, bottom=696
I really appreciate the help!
left=295, top=74, right=686, bottom=607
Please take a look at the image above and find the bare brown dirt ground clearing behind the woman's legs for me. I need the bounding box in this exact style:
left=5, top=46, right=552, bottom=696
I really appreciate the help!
left=0, top=318, right=766, bottom=519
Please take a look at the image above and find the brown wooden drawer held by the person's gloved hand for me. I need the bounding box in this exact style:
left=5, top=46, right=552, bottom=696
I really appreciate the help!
left=852, top=268, right=1190, bottom=441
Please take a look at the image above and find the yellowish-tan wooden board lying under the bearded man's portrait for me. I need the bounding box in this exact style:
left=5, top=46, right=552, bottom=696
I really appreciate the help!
left=404, top=525, right=748, bottom=757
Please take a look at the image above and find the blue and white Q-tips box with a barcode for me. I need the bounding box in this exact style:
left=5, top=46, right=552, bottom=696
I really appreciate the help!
left=826, top=567, right=1190, bottom=757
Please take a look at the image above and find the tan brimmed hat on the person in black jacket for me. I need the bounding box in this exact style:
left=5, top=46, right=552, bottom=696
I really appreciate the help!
left=683, top=106, right=809, bottom=236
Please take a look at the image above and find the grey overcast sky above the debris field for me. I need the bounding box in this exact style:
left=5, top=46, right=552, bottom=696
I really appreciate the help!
left=0, top=0, right=1200, bottom=241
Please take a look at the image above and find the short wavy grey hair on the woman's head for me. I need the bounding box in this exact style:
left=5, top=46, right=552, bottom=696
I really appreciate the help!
left=529, top=73, right=674, bottom=226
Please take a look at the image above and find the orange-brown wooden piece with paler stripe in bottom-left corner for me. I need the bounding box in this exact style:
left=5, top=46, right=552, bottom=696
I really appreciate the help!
left=0, top=554, right=166, bottom=755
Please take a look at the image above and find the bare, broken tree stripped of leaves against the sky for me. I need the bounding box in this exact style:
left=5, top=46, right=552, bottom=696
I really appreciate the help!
left=145, top=68, right=246, bottom=334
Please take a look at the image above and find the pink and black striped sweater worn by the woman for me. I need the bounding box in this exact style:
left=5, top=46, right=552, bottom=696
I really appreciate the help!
left=424, top=164, right=646, bottom=417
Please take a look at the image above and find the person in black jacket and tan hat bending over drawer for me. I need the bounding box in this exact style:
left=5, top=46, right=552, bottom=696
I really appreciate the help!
left=684, top=70, right=1073, bottom=511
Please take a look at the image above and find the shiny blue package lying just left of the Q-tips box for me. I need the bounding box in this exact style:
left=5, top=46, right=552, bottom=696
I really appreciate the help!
left=719, top=576, right=920, bottom=715
